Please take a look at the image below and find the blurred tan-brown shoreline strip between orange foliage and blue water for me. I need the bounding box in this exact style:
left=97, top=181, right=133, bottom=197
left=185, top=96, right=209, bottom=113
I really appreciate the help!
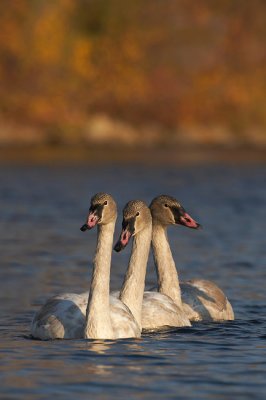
left=0, top=114, right=266, bottom=165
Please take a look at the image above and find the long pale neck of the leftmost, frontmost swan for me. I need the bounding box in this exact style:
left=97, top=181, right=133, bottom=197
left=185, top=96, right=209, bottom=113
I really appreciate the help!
left=85, top=221, right=115, bottom=339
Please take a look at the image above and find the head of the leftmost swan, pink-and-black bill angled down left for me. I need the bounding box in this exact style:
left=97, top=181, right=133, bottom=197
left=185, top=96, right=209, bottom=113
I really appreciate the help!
left=80, top=193, right=117, bottom=232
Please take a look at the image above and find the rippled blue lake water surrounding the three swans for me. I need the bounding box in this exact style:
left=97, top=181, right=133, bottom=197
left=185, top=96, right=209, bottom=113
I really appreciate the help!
left=0, top=165, right=266, bottom=400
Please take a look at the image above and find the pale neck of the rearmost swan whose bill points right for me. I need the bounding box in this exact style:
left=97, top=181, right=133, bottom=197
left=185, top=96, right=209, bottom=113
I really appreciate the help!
left=152, top=223, right=182, bottom=307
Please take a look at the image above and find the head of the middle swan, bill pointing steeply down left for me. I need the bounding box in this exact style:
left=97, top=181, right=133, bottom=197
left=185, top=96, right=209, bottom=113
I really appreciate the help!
left=114, top=200, right=152, bottom=252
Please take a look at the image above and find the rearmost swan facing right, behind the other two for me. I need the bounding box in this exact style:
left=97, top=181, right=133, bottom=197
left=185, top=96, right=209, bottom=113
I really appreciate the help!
left=150, top=195, right=234, bottom=321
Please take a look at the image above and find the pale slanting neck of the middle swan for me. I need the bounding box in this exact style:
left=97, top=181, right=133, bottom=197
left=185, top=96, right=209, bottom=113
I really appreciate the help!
left=120, top=226, right=152, bottom=328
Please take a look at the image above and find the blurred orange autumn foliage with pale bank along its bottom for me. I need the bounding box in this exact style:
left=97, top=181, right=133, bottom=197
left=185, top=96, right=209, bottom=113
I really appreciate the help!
left=0, top=0, right=266, bottom=162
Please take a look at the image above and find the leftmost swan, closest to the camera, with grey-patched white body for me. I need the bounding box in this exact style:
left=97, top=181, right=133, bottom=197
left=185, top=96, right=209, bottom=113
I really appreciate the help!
left=31, top=193, right=141, bottom=340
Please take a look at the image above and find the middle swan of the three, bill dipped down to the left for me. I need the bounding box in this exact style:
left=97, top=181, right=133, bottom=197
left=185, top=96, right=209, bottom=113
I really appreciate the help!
left=114, top=200, right=191, bottom=331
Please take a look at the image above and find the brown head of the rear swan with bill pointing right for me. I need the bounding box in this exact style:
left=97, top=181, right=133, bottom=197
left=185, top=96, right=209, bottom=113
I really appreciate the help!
left=150, top=195, right=200, bottom=229
